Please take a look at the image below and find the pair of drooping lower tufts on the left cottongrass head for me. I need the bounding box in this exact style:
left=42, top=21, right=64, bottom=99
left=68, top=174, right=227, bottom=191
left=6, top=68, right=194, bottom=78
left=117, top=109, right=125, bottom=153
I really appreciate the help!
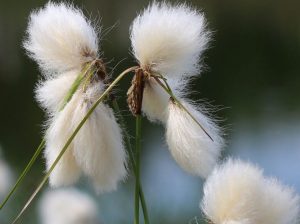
left=45, top=83, right=127, bottom=193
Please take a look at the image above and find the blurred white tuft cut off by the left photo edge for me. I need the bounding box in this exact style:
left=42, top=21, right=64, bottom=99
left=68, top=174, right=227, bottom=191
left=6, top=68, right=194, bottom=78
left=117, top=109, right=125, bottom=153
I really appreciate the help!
left=0, top=150, right=13, bottom=198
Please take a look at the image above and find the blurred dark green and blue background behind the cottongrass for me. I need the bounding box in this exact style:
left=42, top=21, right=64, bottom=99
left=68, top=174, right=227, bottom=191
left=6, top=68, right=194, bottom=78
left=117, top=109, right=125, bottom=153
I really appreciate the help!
left=0, top=0, right=300, bottom=224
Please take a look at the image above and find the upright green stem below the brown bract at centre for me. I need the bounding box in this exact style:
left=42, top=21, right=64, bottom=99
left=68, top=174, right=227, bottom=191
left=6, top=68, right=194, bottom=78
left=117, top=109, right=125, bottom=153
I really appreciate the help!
left=134, top=114, right=142, bottom=224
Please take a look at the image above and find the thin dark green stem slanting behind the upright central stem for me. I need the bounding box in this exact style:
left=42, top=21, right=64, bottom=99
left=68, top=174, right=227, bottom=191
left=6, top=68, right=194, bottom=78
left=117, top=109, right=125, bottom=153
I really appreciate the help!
left=112, top=99, right=150, bottom=224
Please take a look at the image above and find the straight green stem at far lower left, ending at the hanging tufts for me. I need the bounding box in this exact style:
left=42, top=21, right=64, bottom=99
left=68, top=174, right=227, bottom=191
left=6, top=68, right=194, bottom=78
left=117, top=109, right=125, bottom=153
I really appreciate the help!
left=0, top=139, right=45, bottom=209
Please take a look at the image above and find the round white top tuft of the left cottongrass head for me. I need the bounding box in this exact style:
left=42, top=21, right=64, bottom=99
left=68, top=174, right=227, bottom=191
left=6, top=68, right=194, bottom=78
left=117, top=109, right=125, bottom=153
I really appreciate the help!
left=24, top=2, right=98, bottom=75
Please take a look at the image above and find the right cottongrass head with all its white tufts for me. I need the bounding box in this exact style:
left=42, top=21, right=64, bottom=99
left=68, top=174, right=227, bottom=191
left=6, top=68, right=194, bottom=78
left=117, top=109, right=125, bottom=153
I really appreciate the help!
left=130, top=3, right=224, bottom=177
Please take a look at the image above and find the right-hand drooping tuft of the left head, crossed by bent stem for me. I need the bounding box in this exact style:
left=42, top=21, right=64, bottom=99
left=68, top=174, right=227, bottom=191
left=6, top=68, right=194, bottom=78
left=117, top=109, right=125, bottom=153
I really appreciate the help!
left=72, top=84, right=127, bottom=193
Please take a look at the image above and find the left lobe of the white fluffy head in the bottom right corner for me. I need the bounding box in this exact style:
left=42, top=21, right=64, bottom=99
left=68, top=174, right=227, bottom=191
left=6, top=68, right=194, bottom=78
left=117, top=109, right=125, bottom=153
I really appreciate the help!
left=201, top=159, right=266, bottom=224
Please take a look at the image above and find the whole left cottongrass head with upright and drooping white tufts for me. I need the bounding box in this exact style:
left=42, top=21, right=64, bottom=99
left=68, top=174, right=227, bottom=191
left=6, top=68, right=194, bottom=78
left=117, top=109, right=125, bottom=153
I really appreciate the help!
left=24, top=2, right=126, bottom=192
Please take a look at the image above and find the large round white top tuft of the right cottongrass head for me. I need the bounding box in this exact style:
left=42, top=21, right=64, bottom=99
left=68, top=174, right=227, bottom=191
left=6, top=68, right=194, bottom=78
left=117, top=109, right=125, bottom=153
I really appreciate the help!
left=130, top=2, right=210, bottom=77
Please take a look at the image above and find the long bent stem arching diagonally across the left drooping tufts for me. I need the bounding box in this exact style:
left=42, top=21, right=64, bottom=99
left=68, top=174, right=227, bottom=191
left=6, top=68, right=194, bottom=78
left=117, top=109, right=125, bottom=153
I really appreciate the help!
left=12, top=67, right=137, bottom=224
